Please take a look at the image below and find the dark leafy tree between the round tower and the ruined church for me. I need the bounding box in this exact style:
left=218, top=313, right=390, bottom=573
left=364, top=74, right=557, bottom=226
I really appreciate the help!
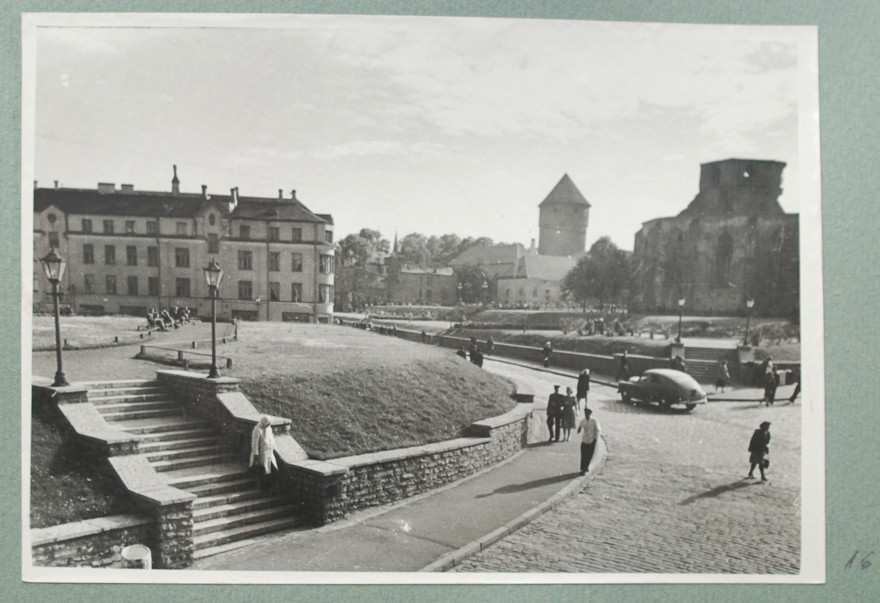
left=562, top=237, right=631, bottom=312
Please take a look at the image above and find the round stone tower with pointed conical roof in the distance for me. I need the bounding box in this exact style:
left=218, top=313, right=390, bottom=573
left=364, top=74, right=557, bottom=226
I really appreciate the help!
left=538, top=174, right=590, bottom=257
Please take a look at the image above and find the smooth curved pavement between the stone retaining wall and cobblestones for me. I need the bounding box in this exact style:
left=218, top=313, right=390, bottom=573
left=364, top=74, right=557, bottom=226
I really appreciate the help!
left=192, top=360, right=606, bottom=572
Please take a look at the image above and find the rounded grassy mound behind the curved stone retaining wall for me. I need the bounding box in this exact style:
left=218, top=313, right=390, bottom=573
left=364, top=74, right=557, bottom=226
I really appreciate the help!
left=229, top=323, right=514, bottom=459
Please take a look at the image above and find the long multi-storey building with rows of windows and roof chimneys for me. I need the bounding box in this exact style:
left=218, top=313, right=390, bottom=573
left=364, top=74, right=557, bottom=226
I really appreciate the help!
left=34, top=166, right=335, bottom=322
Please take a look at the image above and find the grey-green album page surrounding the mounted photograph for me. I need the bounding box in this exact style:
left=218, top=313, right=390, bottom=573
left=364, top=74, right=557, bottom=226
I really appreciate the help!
left=0, top=0, right=880, bottom=603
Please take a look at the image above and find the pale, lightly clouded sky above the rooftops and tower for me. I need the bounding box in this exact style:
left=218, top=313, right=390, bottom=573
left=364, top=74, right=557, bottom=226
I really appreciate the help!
left=34, top=16, right=803, bottom=249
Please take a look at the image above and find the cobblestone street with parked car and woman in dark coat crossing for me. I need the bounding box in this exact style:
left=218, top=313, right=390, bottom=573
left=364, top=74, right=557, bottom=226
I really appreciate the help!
left=455, top=363, right=801, bottom=574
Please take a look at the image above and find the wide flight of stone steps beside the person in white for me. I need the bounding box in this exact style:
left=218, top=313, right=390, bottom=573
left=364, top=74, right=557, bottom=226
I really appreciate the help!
left=85, top=380, right=305, bottom=559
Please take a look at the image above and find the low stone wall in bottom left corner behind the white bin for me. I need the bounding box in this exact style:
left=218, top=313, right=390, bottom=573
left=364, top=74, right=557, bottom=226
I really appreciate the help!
left=30, top=515, right=156, bottom=567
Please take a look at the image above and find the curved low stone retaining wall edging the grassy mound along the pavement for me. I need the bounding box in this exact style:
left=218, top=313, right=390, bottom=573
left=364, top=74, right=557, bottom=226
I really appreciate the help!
left=285, top=404, right=532, bottom=524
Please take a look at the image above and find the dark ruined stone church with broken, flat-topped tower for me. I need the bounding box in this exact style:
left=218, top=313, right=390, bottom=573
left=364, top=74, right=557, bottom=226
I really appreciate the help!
left=630, top=159, right=799, bottom=317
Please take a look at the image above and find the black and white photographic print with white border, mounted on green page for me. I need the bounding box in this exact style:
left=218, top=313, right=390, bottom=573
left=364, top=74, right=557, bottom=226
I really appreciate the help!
left=21, top=13, right=826, bottom=584
